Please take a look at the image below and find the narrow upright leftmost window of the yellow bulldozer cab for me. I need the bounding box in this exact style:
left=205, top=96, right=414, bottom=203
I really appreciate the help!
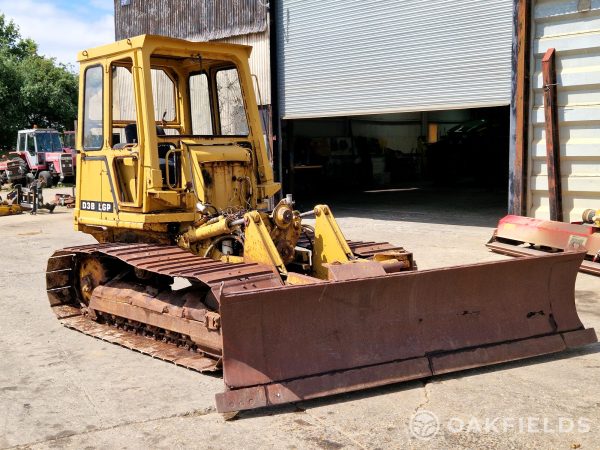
left=83, top=66, right=104, bottom=150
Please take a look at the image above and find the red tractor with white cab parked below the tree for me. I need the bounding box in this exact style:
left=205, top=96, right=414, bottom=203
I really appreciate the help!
left=0, top=128, right=76, bottom=187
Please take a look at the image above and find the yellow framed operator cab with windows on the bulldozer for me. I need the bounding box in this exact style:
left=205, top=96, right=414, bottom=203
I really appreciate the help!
left=78, top=36, right=279, bottom=220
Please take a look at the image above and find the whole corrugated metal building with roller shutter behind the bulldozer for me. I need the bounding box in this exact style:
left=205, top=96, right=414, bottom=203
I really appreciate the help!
left=115, top=0, right=600, bottom=214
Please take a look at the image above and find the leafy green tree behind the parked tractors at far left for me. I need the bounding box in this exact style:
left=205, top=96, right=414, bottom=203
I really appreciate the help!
left=0, top=13, right=78, bottom=148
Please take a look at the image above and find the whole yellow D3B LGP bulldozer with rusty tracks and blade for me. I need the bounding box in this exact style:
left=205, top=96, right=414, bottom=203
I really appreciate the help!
left=47, top=36, right=597, bottom=412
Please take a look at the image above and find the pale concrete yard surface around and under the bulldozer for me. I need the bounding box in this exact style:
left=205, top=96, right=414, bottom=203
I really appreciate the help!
left=0, top=186, right=600, bottom=450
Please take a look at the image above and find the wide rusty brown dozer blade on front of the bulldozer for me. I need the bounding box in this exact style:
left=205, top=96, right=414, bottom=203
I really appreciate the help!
left=217, top=252, right=597, bottom=412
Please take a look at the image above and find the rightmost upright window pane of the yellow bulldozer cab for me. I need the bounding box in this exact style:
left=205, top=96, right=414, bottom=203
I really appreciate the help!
left=216, top=68, right=249, bottom=136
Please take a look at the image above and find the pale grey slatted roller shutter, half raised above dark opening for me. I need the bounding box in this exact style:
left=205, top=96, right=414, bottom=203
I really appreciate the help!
left=276, top=0, right=513, bottom=118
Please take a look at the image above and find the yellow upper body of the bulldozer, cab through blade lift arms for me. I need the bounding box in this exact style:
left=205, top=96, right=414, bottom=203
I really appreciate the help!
left=75, top=36, right=408, bottom=283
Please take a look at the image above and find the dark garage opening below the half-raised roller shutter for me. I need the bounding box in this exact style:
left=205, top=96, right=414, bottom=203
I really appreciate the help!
left=284, top=107, right=509, bottom=195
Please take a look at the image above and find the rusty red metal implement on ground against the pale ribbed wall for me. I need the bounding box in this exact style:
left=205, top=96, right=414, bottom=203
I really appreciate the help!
left=487, top=215, right=600, bottom=275
